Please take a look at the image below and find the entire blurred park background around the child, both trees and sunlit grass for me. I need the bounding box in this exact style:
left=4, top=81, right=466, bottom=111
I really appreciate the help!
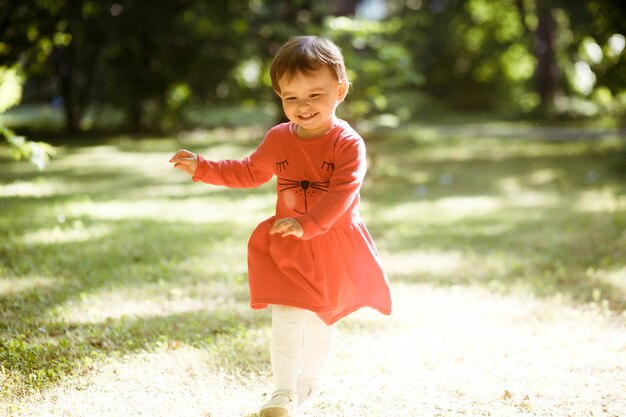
left=0, top=0, right=626, bottom=410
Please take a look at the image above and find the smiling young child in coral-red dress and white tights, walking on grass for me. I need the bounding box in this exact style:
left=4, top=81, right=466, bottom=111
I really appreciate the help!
left=170, top=36, right=391, bottom=417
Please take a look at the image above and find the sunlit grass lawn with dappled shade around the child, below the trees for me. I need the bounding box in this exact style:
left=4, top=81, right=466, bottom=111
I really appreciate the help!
left=0, top=118, right=626, bottom=417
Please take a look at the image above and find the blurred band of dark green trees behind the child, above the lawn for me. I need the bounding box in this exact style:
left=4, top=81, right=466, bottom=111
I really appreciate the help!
left=0, top=0, right=626, bottom=141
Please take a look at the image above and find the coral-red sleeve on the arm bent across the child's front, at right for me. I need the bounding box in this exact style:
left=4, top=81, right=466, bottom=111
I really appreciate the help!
left=297, top=137, right=366, bottom=239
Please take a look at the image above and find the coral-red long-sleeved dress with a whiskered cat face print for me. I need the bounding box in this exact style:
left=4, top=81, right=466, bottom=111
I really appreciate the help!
left=193, top=121, right=391, bottom=324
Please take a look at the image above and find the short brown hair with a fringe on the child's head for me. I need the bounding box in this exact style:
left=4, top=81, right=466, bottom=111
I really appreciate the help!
left=270, top=36, right=349, bottom=93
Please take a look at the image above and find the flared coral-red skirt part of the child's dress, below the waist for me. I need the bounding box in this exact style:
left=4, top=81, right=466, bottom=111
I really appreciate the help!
left=248, top=217, right=391, bottom=324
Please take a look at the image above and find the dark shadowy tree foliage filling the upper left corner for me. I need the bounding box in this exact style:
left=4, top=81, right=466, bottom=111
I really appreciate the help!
left=0, top=0, right=254, bottom=133
